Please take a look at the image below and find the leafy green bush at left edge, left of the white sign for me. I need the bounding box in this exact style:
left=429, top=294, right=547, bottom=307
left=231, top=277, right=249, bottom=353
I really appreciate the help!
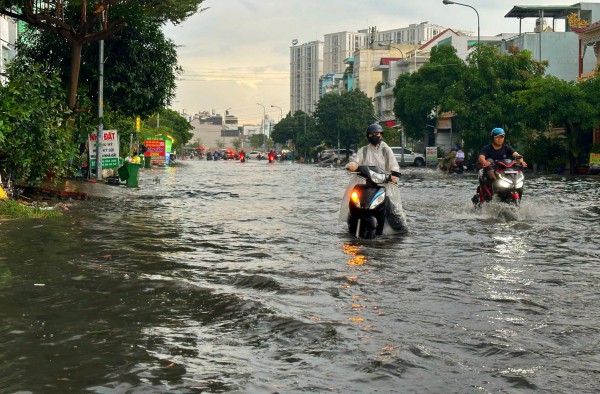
left=0, top=65, right=74, bottom=184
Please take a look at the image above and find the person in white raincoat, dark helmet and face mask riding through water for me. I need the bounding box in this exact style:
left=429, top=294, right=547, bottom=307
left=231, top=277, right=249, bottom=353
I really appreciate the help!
left=339, top=123, right=408, bottom=232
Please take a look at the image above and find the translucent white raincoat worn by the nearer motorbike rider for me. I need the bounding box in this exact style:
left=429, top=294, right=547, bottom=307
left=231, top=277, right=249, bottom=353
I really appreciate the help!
left=339, top=141, right=408, bottom=232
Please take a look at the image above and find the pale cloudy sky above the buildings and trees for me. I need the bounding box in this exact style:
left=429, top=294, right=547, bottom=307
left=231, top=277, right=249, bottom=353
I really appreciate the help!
left=165, top=0, right=576, bottom=124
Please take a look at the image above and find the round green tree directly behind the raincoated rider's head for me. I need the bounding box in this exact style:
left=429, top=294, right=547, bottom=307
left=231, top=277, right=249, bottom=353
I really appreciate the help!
left=314, top=89, right=375, bottom=157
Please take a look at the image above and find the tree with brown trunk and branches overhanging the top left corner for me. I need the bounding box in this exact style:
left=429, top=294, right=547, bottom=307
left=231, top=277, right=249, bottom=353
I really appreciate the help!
left=0, top=0, right=204, bottom=110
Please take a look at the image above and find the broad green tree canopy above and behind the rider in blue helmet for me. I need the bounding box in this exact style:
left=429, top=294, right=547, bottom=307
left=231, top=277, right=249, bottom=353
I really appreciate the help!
left=394, top=46, right=545, bottom=152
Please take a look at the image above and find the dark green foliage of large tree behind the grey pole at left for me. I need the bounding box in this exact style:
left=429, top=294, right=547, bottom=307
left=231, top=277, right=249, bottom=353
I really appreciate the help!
left=15, top=5, right=181, bottom=117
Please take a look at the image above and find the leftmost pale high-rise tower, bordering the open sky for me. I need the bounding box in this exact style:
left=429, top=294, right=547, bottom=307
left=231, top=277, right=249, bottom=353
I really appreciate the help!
left=290, top=41, right=323, bottom=114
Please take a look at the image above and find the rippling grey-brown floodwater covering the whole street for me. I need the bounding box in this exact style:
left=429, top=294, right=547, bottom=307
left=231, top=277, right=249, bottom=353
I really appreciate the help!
left=0, top=161, right=600, bottom=393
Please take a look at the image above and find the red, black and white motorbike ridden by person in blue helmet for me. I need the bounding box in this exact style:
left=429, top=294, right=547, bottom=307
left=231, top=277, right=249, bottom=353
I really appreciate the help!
left=471, top=156, right=525, bottom=206
